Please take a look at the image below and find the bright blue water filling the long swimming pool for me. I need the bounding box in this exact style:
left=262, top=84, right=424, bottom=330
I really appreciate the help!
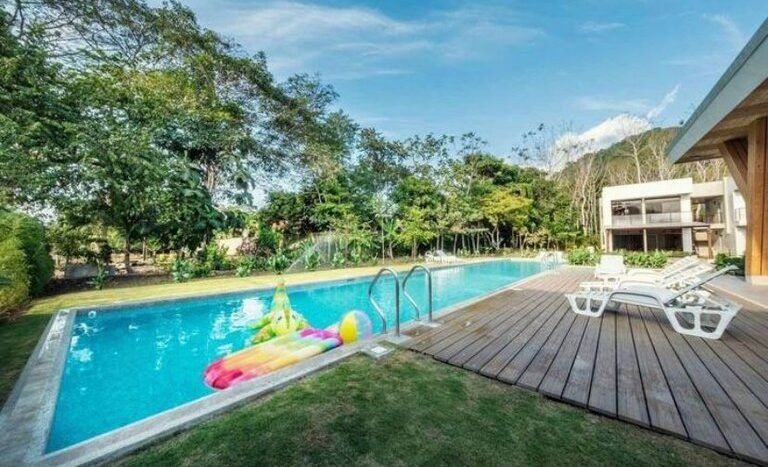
left=47, top=261, right=541, bottom=452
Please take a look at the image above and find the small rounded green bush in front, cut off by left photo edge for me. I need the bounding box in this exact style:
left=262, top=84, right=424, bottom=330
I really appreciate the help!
left=0, top=237, right=29, bottom=316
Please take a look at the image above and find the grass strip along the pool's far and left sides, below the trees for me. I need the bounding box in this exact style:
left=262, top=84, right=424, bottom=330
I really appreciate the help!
left=0, top=263, right=438, bottom=405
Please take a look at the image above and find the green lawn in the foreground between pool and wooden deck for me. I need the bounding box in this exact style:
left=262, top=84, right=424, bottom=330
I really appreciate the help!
left=120, top=351, right=738, bottom=466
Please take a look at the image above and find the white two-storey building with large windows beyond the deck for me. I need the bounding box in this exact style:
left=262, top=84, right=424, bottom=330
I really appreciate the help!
left=600, top=177, right=746, bottom=257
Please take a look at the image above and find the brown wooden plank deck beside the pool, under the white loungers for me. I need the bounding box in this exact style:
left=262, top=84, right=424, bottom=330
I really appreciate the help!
left=406, top=268, right=768, bottom=464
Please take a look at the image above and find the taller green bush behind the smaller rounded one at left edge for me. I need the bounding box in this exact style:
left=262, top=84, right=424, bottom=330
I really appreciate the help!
left=0, top=213, right=53, bottom=296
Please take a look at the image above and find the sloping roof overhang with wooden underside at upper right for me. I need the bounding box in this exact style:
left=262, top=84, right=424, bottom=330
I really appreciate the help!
left=667, top=19, right=768, bottom=162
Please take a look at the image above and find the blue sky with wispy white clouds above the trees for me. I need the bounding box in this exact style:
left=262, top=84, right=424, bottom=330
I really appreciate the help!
left=176, top=0, right=768, bottom=155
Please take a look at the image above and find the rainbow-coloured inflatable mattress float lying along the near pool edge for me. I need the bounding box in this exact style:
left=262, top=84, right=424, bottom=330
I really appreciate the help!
left=204, top=329, right=341, bottom=389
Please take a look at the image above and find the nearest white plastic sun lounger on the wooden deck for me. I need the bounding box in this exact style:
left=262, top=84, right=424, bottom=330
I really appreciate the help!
left=565, top=266, right=741, bottom=339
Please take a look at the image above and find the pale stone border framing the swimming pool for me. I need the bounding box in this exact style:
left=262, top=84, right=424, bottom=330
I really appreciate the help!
left=0, top=258, right=552, bottom=466
